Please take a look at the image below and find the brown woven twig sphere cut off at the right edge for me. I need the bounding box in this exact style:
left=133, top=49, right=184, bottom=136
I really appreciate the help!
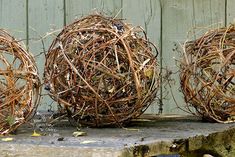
left=180, top=25, right=235, bottom=123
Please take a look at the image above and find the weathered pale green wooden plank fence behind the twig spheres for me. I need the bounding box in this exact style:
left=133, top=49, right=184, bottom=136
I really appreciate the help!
left=0, top=0, right=235, bottom=113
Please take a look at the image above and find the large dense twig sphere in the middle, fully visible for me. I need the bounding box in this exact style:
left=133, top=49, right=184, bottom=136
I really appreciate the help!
left=45, top=15, right=159, bottom=127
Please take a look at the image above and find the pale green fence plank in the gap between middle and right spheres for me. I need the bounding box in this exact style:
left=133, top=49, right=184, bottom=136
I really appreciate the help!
left=161, top=0, right=194, bottom=114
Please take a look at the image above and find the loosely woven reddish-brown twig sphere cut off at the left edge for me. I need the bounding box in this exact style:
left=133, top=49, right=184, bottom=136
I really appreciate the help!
left=0, top=29, right=40, bottom=134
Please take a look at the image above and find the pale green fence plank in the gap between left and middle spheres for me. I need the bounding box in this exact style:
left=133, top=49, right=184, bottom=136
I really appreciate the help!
left=29, top=0, right=64, bottom=110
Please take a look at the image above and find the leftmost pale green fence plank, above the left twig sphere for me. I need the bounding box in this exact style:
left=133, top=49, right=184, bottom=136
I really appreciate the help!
left=0, top=0, right=26, bottom=39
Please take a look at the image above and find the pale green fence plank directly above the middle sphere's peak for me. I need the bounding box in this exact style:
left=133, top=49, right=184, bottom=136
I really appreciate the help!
left=66, top=0, right=122, bottom=24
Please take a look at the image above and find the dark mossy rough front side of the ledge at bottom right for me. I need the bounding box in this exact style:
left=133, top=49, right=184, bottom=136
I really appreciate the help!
left=123, top=128, right=235, bottom=157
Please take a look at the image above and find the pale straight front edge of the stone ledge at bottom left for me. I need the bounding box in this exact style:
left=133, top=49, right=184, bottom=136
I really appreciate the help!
left=0, top=144, right=122, bottom=157
